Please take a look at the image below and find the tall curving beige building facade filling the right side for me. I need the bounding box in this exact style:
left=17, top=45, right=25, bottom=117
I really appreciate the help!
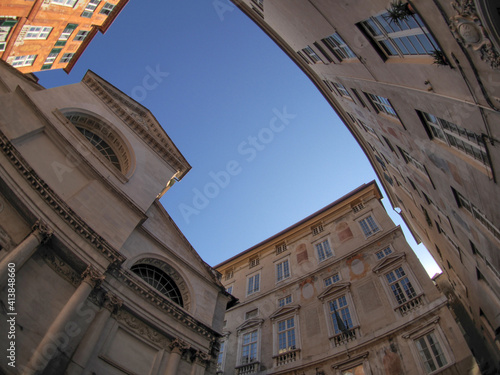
left=230, top=0, right=500, bottom=371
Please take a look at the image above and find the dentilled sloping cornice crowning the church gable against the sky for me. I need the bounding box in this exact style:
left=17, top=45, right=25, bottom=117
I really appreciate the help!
left=82, top=70, right=191, bottom=180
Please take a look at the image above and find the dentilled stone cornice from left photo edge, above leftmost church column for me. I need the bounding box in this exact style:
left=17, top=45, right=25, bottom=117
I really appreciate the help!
left=0, top=130, right=126, bottom=264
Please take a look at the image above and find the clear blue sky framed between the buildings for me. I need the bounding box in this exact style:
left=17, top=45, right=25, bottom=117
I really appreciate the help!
left=37, top=0, right=440, bottom=276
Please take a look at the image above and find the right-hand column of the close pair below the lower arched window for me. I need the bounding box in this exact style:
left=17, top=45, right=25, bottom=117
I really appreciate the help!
left=66, top=292, right=123, bottom=375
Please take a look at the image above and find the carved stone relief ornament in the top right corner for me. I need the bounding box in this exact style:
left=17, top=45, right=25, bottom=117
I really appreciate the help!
left=450, top=0, right=500, bottom=69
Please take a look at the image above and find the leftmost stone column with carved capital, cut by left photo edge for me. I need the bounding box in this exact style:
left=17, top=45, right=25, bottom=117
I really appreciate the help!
left=0, top=220, right=52, bottom=287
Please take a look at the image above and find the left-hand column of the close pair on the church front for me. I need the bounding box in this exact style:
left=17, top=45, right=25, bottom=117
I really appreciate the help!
left=22, top=266, right=104, bottom=375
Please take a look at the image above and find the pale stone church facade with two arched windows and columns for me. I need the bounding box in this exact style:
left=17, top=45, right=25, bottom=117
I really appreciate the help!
left=0, top=62, right=230, bottom=375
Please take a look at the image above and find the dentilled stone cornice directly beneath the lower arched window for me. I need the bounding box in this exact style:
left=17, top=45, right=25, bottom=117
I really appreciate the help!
left=109, top=268, right=220, bottom=340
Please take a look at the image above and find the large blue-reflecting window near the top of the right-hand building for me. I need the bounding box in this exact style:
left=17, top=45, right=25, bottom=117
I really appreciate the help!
left=360, top=12, right=440, bottom=58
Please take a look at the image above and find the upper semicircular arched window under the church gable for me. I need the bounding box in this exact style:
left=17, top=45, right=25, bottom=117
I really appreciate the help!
left=64, top=111, right=131, bottom=174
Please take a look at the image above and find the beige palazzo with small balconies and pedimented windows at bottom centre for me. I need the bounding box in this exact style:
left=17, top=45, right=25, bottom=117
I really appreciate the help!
left=215, top=182, right=478, bottom=375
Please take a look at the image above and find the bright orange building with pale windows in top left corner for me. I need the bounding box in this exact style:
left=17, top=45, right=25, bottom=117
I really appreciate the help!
left=0, top=0, right=128, bottom=73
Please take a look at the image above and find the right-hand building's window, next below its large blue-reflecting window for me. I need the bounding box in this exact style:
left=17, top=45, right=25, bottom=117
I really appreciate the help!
left=419, top=112, right=490, bottom=167
